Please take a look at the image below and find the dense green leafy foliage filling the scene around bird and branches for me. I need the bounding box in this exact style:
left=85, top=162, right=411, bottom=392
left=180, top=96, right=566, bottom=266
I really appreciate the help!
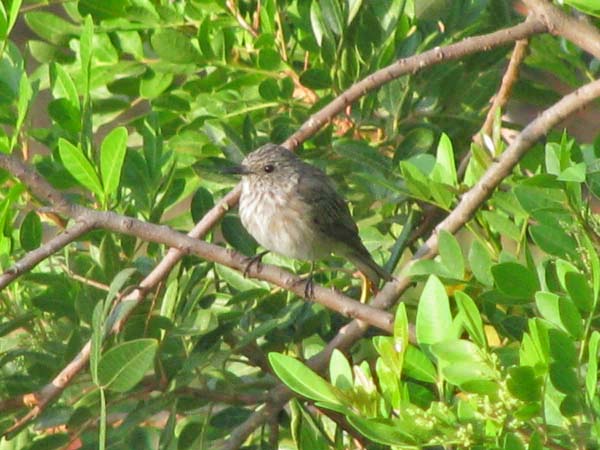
left=0, top=0, right=600, bottom=450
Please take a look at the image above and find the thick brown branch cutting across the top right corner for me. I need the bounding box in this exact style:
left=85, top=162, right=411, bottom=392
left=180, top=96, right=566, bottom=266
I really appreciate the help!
left=523, top=0, right=600, bottom=59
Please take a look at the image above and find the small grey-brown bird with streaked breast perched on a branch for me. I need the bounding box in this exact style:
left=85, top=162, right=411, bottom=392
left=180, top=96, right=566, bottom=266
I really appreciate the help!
left=228, top=144, right=391, bottom=297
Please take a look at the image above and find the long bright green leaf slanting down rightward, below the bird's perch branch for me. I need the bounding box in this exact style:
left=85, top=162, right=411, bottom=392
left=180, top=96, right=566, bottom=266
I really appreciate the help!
left=269, top=353, right=344, bottom=407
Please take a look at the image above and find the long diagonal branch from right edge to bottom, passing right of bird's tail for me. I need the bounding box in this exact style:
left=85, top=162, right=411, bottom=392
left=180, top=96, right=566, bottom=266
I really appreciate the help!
left=219, top=80, right=600, bottom=450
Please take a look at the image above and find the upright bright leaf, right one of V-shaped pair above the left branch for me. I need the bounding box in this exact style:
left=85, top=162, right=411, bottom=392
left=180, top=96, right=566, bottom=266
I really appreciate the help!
left=100, top=127, right=127, bottom=197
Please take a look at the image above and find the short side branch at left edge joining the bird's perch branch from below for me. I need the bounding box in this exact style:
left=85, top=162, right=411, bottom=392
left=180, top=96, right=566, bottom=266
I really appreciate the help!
left=0, top=221, right=94, bottom=289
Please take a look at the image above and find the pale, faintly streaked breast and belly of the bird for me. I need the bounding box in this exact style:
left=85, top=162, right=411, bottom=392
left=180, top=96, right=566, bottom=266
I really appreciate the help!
left=239, top=182, right=331, bottom=260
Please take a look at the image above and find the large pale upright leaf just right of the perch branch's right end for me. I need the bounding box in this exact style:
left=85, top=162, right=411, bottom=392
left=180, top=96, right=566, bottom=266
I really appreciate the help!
left=416, top=275, right=452, bottom=345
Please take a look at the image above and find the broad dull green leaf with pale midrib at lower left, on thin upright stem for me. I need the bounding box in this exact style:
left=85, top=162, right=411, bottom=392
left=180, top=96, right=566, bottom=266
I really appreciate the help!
left=98, top=339, right=158, bottom=392
